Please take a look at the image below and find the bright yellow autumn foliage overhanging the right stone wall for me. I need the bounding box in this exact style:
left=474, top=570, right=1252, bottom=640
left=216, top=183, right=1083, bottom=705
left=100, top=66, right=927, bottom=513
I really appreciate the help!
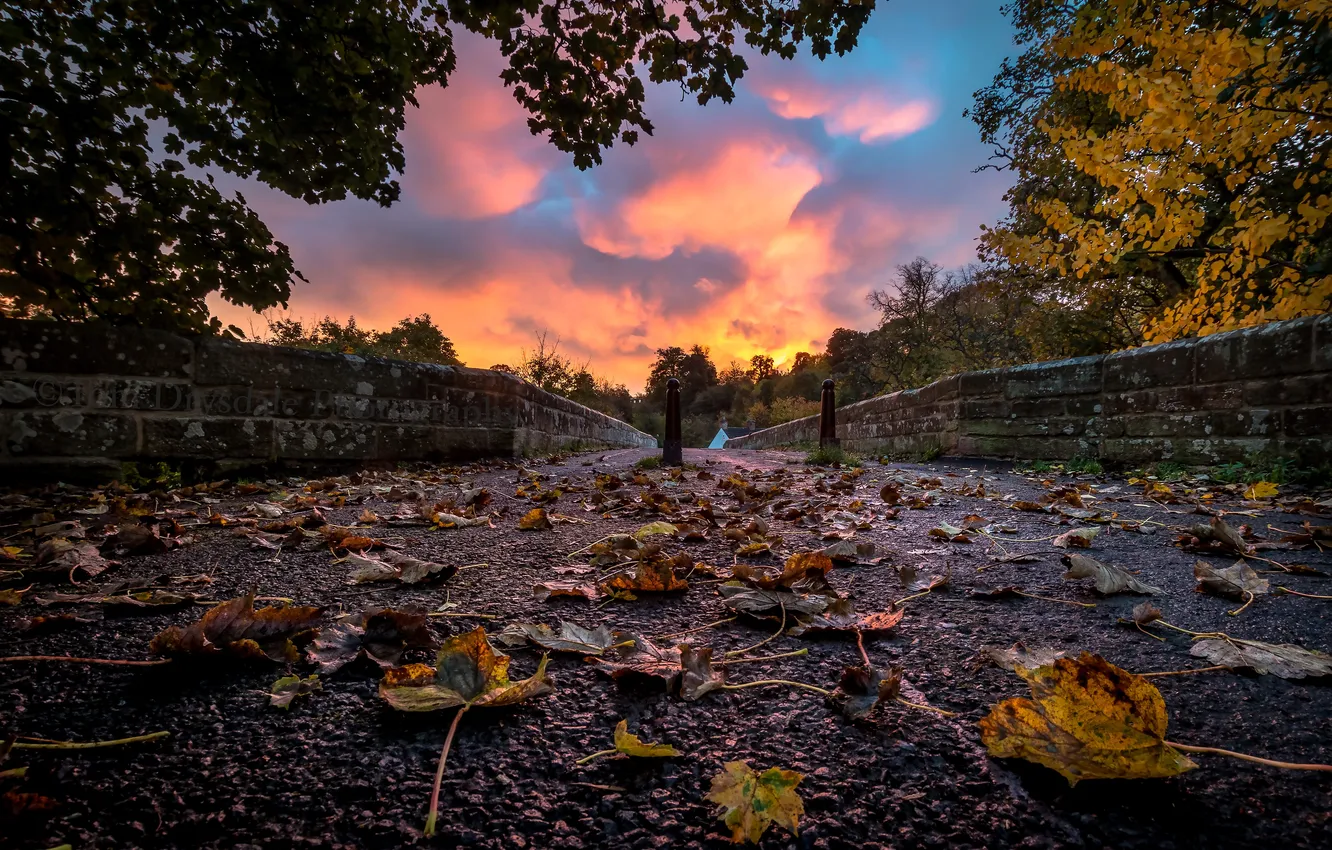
left=984, top=0, right=1332, bottom=342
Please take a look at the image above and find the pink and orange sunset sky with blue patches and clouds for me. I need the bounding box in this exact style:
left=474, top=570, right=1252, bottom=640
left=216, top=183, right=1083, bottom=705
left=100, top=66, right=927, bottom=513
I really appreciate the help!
left=217, top=0, right=1014, bottom=392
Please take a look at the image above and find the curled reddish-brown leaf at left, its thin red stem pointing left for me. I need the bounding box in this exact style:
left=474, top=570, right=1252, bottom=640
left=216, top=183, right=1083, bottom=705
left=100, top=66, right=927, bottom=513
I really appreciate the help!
left=151, top=590, right=324, bottom=661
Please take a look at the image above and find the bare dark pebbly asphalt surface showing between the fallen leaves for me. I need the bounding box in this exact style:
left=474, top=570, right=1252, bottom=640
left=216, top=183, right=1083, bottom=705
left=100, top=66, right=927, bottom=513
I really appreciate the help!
left=0, top=450, right=1332, bottom=850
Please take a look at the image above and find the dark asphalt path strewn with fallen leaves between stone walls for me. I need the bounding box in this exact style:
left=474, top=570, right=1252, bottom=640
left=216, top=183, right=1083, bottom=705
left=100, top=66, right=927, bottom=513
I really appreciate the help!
left=0, top=450, right=1332, bottom=850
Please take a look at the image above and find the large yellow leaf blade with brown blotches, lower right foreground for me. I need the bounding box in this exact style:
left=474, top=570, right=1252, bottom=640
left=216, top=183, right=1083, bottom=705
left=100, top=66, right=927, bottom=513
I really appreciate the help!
left=980, top=653, right=1197, bottom=785
